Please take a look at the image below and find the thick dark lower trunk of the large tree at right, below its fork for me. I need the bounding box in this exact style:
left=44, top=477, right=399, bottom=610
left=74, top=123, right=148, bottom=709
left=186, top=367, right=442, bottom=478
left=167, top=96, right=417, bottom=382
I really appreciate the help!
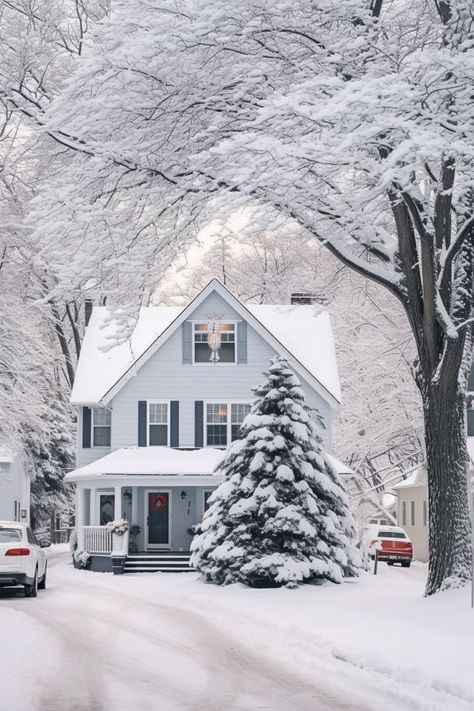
left=422, top=374, right=471, bottom=595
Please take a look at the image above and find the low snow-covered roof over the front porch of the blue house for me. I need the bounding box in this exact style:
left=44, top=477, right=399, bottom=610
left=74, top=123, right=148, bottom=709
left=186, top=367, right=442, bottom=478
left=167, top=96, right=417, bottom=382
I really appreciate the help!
left=65, top=447, right=225, bottom=481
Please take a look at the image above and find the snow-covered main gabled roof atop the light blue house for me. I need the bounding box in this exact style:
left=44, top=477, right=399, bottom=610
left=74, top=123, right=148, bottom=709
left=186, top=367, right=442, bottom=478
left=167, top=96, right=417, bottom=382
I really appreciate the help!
left=71, top=279, right=341, bottom=405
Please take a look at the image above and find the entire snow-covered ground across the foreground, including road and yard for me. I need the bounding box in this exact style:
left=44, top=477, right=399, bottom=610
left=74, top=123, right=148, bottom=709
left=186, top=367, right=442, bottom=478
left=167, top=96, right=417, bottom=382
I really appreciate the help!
left=0, top=547, right=474, bottom=711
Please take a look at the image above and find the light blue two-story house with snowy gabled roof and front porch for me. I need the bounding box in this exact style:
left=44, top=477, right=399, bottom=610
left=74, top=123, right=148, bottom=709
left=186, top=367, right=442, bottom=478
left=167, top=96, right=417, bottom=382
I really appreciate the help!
left=66, top=280, right=344, bottom=572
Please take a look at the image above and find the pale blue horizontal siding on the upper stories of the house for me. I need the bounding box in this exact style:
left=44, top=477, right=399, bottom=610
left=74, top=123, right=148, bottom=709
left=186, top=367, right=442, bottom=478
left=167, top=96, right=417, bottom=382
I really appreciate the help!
left=77, top=292, right=332, bottom=466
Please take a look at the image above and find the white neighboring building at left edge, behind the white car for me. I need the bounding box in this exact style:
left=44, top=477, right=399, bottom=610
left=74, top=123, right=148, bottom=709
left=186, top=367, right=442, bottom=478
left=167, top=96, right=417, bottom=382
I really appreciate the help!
left=0, top=447, right=31, bottom=523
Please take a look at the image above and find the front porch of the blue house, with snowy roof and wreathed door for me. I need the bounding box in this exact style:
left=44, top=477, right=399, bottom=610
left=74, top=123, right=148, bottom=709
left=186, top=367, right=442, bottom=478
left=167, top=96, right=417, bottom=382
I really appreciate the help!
left=66, top=447, right=223, bottom=570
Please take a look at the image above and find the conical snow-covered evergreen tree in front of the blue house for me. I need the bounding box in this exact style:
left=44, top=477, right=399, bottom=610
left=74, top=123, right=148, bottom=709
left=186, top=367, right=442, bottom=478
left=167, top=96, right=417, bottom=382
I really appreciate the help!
left=191, top=357, right=359, bottom=586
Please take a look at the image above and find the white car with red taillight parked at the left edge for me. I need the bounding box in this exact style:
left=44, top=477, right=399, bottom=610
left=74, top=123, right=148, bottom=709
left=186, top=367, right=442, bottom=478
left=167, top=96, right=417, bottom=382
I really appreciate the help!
left=0, top=521, right=51, bottom=597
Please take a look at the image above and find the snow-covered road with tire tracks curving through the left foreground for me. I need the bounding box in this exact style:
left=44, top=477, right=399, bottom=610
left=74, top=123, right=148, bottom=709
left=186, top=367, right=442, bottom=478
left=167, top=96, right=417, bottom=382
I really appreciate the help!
left=0, top=554, right=365, bottom=711
